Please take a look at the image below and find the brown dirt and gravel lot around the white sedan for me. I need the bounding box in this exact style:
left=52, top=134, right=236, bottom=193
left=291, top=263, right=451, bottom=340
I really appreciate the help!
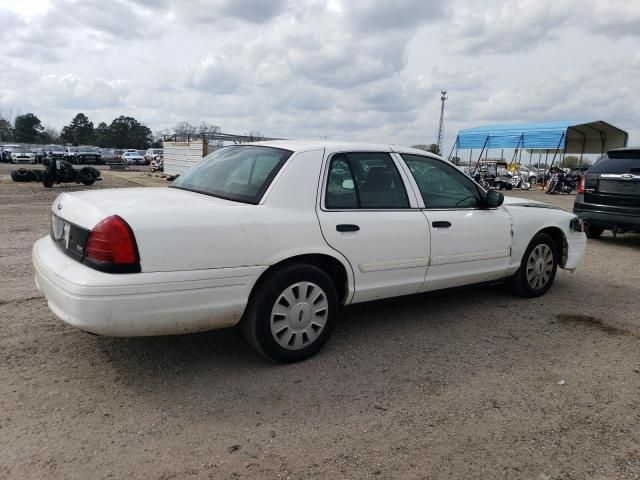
left=0, top=174, right=640, bottom=480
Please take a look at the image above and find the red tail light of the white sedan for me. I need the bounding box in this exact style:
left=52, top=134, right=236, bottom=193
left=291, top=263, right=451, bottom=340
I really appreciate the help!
left=84, top=215, right=140, bottom=266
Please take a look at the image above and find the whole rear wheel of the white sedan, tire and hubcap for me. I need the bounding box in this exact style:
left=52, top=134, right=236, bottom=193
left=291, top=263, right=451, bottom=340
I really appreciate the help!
left=242, top=264, right=338, bottom=363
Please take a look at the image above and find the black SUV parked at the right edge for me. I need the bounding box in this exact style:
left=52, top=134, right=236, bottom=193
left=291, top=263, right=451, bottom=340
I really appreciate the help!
left=573, top=147, right=640, bottom=238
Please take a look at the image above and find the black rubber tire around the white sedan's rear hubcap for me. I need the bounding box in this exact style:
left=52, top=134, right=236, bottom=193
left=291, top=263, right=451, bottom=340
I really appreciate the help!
left=241, top=263, right=338, bottom=363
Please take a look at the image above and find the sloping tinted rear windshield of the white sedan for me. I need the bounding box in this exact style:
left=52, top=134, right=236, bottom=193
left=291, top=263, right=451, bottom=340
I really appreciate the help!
left=171, top=145, right=292, bottom=204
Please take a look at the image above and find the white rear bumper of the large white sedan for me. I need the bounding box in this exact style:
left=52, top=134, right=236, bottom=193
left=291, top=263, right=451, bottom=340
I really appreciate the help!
left=33, top=237, right=266, bottom=337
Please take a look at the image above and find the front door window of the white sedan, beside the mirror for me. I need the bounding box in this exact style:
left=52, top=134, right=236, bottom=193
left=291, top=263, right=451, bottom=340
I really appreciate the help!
left=401, top=153, right=482, bottom=208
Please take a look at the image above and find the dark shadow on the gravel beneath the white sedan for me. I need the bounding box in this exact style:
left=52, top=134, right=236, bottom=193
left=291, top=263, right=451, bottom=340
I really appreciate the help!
left=93, top=287, right=539, bottom=412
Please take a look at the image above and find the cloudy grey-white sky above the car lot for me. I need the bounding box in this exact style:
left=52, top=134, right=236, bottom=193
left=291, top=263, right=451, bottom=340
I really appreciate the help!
left=0, top=0, right=640, bottom=151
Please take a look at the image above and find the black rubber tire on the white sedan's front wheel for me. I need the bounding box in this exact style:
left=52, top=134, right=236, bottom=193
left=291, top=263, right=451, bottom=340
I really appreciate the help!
left=509, top=233, right=559, bottom=298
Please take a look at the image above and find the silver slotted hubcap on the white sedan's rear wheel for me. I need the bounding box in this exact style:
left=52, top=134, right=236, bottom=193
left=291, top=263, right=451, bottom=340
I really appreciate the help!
left=270, top=282, right=329, bottom=350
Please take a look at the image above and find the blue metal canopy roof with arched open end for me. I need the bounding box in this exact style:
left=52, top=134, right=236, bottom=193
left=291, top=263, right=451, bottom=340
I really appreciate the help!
left=455, top=120, right=629, bottom=153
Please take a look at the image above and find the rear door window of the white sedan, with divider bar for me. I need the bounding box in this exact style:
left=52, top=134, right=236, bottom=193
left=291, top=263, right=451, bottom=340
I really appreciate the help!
left=325, top=152, right=409, bottom=209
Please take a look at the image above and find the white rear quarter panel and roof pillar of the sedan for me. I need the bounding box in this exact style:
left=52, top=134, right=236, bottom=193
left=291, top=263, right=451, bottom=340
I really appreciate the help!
left=126, top=150, right=351, bottom=283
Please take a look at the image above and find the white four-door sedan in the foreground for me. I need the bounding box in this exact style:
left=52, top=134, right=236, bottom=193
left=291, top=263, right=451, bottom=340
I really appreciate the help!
left=33, top=141, right=586, bottom=361
